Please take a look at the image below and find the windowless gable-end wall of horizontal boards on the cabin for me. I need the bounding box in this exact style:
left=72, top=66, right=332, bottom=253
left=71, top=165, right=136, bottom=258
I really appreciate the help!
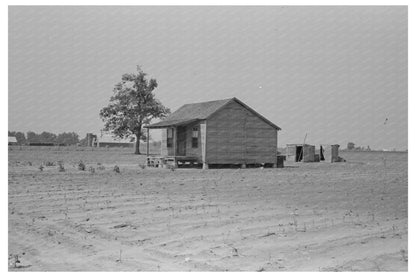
left=206, top=101, right=277, bottom=164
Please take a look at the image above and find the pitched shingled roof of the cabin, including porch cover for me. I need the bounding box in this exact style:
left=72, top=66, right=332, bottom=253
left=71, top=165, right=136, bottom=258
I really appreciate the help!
left=145, top=97, right=281, bottom=130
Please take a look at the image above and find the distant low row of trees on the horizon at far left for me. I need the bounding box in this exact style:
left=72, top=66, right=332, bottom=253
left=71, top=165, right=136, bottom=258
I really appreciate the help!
left=8, top=131, right=79, bottom=145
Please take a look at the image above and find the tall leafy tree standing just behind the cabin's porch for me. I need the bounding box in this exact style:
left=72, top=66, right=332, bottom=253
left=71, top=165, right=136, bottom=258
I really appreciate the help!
left=100, top=66, right=170, bottom=154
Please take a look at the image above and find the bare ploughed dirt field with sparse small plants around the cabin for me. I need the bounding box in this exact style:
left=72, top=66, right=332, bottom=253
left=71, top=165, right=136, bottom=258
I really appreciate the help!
left=8, top=147, right=408, bottom=271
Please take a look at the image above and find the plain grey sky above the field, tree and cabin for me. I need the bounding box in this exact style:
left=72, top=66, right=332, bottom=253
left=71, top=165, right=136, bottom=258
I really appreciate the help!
left=8, top=6, right=408, bottom=149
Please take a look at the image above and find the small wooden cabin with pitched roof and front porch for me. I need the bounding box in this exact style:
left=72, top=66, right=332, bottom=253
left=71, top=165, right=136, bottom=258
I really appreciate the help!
left=145, top=98, right=281, bottom=168
